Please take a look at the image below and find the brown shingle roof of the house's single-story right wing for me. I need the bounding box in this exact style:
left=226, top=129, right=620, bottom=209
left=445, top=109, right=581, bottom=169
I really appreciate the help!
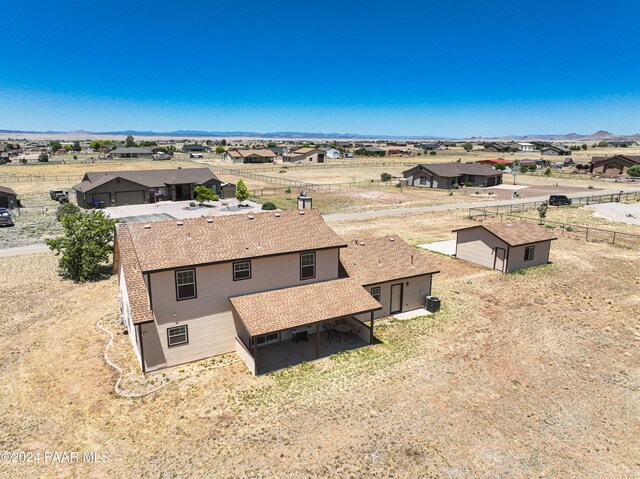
left=340, top=236, right=439, bottom=286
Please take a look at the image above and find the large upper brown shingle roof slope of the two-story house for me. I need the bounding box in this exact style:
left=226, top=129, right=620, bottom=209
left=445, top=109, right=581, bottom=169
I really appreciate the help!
left=119, top=210, right=346, bottom=271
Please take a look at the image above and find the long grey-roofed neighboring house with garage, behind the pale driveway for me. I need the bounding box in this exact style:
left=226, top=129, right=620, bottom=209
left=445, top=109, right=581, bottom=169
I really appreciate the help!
left=73, top=168, right=235, bottom=208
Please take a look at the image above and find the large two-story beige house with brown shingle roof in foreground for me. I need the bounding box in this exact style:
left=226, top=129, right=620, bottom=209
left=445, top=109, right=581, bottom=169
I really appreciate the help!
left=114, top=210, right=438, bottom=374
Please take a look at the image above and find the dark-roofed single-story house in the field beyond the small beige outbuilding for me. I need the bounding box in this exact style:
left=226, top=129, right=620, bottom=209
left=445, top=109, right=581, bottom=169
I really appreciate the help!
left=402, top=163, right=502, bottom=189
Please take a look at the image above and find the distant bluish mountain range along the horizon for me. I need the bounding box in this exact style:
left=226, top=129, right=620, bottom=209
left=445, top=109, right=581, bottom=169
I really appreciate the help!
left=0, top=129, right=640, bottom=141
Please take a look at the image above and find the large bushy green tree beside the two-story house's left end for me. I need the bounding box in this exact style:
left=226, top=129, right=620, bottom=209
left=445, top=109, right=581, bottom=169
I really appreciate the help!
left=46, top=211, right=116, bottom=283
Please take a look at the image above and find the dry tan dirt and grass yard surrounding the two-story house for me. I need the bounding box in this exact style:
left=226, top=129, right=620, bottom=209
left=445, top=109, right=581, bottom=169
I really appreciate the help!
left=0, top=208, right=640, bottom=478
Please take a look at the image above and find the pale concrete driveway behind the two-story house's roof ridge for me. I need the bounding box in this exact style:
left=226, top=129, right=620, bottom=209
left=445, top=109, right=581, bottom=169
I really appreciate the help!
left=104, top=200, right=262, bottom=223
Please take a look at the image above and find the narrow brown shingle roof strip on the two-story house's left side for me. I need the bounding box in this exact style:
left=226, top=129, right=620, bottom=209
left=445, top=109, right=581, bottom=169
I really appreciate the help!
left=116, top=224, right=154, bottom=324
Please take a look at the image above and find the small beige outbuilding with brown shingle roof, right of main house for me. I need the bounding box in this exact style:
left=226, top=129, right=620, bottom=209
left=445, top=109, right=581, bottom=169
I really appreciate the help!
left=453, top=221, right=558, bottom=273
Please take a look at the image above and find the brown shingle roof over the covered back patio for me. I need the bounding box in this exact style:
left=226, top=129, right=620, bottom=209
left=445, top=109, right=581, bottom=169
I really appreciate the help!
left=229, top=278, right=382, bottom=336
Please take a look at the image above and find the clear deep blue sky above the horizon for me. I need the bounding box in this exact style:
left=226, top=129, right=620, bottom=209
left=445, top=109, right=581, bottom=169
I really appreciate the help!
left=0, top=0, right=640, bottom=136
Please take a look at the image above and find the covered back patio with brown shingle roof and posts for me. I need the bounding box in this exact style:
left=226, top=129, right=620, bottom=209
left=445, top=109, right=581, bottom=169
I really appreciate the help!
left=230, top=279, right=381, bottom=375
